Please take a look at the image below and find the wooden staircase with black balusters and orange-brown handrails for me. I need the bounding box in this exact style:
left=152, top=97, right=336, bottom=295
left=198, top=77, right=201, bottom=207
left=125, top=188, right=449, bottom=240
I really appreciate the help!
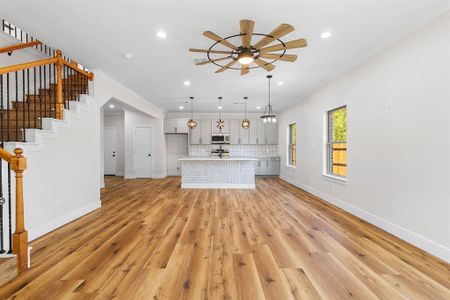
left=0, top=20, right=94, bottom=286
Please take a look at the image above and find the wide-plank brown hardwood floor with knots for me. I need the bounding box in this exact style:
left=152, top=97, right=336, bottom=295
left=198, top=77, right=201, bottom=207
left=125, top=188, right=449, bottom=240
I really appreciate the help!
left=0, top=177, right=450, bottom=299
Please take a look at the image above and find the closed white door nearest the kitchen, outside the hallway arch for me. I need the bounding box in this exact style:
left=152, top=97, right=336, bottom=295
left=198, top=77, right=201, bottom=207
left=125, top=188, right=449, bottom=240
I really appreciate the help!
left=134, top=126, right=153, bottom=178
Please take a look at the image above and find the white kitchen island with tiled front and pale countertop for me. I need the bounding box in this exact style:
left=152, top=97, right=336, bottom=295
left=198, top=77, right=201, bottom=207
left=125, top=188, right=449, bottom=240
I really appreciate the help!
left=179, top=156, right=258, bottom=189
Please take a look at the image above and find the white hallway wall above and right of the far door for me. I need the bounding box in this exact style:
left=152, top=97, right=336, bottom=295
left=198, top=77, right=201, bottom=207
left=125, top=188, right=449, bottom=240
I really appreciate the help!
left=103, top=112, right=125, bottom=176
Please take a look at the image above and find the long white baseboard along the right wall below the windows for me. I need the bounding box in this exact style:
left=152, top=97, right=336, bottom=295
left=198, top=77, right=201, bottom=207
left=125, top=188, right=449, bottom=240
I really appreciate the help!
left=280, top=175, right=450, bottom=263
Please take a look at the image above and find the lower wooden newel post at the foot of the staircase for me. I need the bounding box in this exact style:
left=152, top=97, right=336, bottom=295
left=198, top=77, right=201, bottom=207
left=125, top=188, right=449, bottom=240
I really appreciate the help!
left=11, top=148, right=28, bottom=273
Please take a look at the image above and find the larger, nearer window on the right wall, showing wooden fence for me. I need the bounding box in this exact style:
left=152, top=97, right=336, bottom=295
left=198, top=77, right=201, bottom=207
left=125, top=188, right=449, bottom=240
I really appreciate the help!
left=327, top=106, right=347, bottom=177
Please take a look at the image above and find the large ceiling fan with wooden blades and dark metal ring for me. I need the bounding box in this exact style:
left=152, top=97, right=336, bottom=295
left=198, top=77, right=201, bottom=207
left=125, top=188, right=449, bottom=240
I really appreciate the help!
left=189, top=20, right=307, bottom=75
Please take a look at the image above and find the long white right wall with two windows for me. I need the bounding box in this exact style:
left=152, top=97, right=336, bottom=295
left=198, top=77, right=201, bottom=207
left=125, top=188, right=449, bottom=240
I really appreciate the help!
left=279, top=13, right=450, bottom=261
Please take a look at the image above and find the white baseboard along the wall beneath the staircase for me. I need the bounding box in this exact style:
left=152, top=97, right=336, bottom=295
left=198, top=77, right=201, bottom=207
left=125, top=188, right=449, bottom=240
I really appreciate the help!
left=28, top=200, right=102, bottom=241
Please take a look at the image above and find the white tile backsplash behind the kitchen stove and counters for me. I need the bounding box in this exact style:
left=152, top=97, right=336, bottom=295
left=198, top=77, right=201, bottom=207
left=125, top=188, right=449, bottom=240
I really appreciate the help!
left=189, top=145, right=280, bottom=156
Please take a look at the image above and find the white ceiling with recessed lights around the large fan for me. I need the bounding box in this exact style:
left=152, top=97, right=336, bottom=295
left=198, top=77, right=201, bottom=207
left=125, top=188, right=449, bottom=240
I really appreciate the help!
left=0, top=0, right=450, bottom=111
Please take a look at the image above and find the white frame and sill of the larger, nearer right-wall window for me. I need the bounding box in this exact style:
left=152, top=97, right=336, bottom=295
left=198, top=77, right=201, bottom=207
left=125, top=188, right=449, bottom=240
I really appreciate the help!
left=324, top=104, right=348, bottom=181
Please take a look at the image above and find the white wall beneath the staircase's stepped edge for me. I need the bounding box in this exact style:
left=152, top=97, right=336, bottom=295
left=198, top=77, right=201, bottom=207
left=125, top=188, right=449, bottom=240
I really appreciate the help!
left=5, top=98, right=101, bottom=240
